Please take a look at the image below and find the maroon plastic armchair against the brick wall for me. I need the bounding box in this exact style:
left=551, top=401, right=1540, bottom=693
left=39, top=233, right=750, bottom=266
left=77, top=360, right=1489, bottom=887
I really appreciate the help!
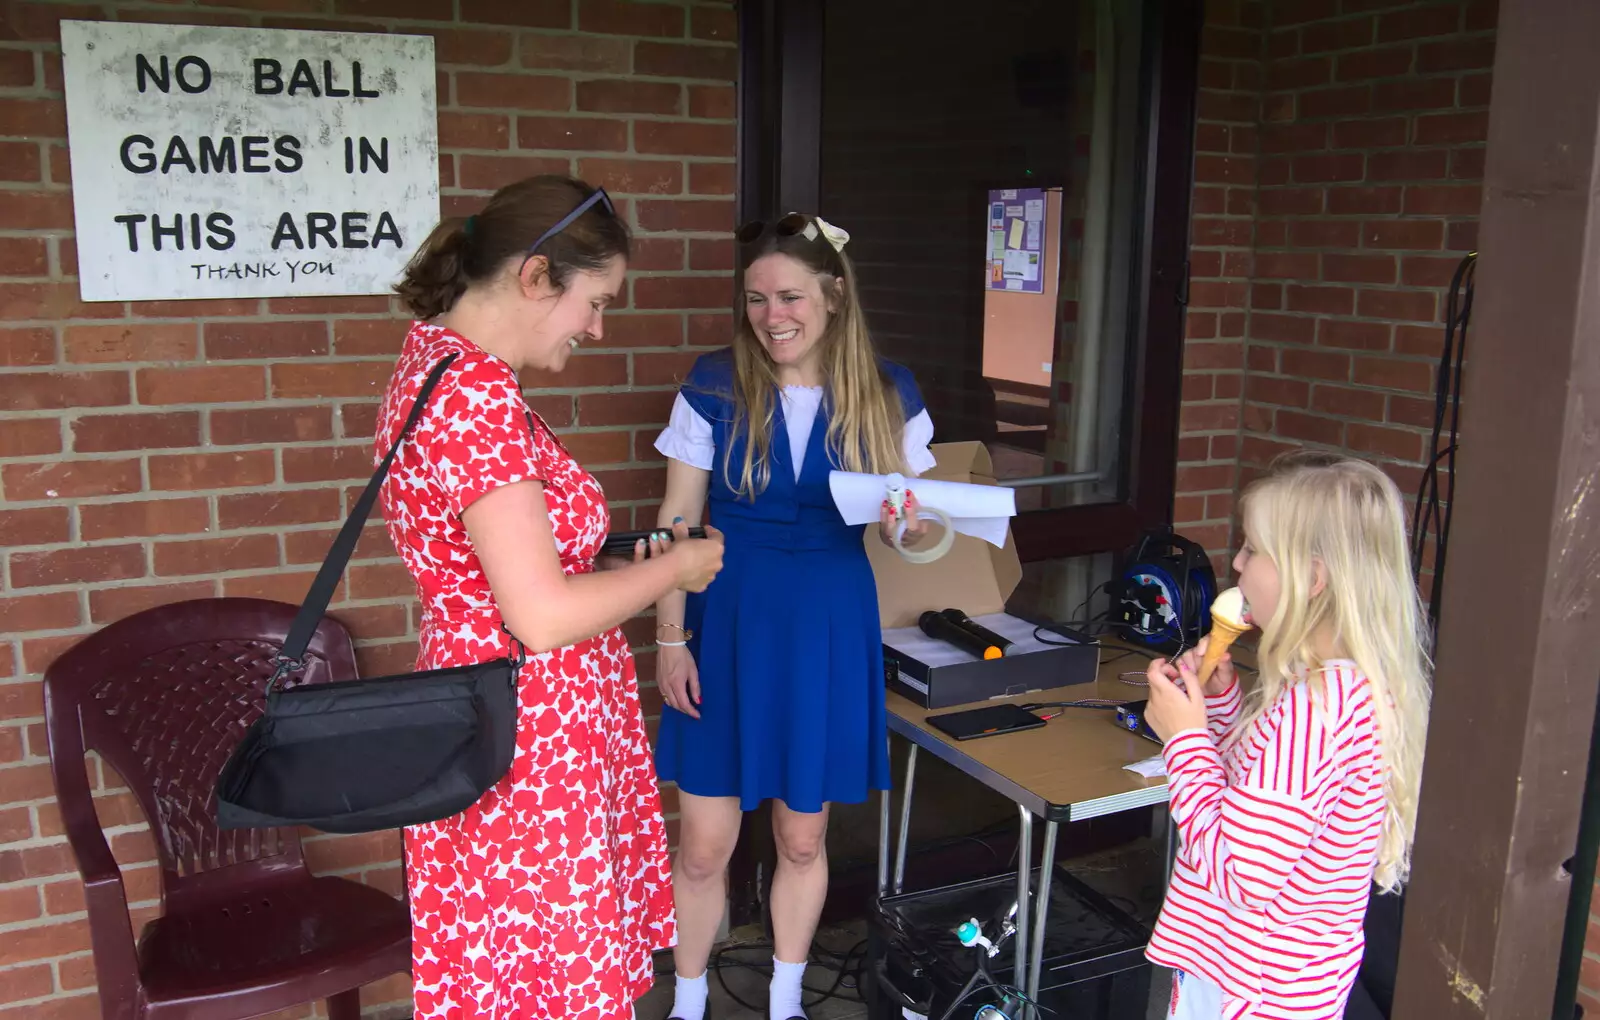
left=45, top=598, right=411, bottom=1020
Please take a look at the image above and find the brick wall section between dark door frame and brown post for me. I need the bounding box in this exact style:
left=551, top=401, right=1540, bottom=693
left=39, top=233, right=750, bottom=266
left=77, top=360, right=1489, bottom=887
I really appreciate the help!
left=1178, top=0, right=1496, bottom=594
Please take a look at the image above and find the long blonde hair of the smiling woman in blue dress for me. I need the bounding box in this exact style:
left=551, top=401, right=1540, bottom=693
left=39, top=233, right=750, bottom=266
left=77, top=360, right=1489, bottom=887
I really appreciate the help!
left=722, top=219, right=906, bottom=499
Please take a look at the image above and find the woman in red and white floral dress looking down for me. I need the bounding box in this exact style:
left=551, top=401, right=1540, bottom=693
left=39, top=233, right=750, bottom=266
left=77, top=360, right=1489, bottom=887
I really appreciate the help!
left=376, top=177, right=722, bottom=1020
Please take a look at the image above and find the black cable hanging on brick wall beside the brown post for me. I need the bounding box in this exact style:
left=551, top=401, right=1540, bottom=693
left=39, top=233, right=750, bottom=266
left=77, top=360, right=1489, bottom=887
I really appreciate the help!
left=1411, top=251, right=1478, bottom=635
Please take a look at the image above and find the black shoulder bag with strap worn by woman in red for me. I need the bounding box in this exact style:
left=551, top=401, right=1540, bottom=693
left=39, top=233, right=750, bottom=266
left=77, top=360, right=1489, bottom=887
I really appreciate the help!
left=216, top=355, right=523, bottom=833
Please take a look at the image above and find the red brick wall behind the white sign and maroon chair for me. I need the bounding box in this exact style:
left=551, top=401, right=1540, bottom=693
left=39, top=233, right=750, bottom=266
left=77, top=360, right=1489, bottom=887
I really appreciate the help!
left=0, top=0, right=736, bottom=1020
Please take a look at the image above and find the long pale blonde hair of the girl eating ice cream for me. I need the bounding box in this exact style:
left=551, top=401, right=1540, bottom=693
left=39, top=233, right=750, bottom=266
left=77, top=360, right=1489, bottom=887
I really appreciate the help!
left=1234, top=454, right=1432, bottom=892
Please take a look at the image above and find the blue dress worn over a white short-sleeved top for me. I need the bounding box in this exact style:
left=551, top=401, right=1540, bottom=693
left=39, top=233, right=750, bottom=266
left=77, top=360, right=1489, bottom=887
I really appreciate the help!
left=656, top=350, right=923, bottom=812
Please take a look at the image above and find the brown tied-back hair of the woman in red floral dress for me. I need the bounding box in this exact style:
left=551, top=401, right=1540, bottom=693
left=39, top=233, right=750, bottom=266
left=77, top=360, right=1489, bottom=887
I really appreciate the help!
left=395, top=176, right=629, bottom=321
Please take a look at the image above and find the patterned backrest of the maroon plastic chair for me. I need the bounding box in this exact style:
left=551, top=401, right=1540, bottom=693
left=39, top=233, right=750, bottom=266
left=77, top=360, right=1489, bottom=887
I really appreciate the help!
left=45, top=598, right=357, bottom=897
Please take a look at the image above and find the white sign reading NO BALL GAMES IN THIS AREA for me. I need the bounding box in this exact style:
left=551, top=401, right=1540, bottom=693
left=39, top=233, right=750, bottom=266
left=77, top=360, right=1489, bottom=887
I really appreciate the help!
left=61, top=21, right=438, bottom=301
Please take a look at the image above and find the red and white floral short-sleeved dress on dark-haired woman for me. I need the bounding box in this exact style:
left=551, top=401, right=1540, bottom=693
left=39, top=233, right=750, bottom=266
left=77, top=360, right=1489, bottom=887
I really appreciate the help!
left=374, top=325, right=675, bottom=1020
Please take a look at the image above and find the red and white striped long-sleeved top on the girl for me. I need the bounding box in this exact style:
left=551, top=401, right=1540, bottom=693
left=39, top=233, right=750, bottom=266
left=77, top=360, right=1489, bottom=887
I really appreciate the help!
left=1147, top=660, right=1384, bottom=1020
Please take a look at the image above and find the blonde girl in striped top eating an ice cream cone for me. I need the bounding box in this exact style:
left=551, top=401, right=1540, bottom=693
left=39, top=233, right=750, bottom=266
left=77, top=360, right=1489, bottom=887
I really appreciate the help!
left=1147, top=454, right=1429, bottom=1020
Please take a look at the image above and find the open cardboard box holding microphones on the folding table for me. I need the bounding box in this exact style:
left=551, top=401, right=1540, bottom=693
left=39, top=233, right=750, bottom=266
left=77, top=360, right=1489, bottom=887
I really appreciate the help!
left=866, top=443, right=1099, bottom=708
